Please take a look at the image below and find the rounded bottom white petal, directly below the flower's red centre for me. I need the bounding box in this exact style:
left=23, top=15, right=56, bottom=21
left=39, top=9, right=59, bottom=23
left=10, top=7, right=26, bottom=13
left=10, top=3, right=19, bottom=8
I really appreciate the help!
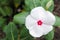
left=29, top=21, right=44, bottom=37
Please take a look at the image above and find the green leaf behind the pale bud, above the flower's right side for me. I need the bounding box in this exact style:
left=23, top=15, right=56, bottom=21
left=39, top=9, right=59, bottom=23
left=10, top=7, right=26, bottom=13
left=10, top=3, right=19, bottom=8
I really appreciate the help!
left=41, top=0, right=54, bottom=12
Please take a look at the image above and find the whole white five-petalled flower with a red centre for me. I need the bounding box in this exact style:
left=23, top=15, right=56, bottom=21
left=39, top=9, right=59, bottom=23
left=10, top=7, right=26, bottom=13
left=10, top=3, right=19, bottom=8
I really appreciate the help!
left=25, top=7, right=55, bottom=37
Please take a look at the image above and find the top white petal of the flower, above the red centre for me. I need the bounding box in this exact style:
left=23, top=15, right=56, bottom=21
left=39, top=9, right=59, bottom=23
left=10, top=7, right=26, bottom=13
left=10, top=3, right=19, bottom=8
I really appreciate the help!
left=30, top=7, right=47, bottom=23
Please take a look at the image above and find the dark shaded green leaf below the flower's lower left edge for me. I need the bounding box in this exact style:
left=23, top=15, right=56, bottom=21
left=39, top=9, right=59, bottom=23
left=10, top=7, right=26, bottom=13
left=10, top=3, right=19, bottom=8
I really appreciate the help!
left=20, top=26, right=34, bottom=40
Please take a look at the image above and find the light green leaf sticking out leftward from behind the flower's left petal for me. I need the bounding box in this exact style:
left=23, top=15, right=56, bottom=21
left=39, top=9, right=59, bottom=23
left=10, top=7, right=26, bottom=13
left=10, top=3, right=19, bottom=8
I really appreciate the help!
left=13, top=12, right=29, bottom=24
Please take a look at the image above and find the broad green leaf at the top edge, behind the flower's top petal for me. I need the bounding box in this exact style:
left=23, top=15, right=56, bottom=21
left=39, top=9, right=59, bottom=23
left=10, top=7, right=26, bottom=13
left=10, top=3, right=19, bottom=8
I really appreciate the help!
left=25, top=0, right=41, bottom=11
